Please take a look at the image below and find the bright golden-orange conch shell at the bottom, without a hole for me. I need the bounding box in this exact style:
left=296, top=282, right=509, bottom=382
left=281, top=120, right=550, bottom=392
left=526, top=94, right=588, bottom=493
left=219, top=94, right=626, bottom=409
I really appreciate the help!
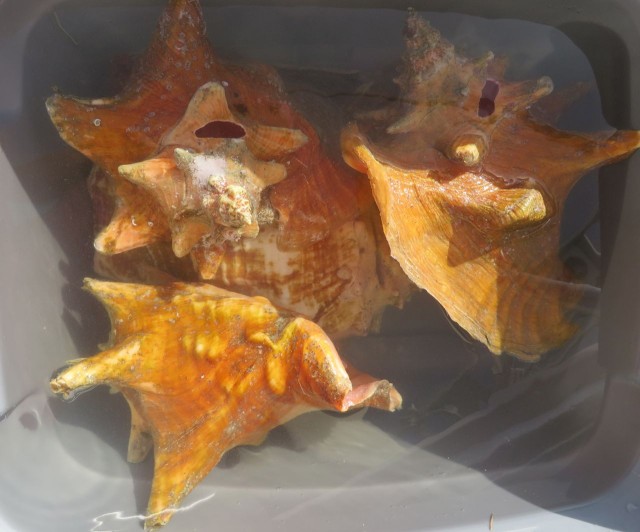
left=51, top=280, right=402, bottom=530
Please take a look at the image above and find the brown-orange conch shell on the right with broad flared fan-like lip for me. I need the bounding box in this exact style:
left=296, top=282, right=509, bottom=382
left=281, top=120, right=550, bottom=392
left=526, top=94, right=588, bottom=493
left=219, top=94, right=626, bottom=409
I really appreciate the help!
left=342, top=14, right=640, bottom=360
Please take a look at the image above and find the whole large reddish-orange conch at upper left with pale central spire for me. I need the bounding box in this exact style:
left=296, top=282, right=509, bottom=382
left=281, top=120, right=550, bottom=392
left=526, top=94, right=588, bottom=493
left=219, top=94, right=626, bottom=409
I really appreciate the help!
left=47, top=0, right=410, bottom=335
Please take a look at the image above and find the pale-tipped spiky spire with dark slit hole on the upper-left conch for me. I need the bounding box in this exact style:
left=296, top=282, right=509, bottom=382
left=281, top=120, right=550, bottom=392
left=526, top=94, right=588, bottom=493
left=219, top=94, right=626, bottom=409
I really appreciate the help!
left=119, top=82, right=307, bottom=270
